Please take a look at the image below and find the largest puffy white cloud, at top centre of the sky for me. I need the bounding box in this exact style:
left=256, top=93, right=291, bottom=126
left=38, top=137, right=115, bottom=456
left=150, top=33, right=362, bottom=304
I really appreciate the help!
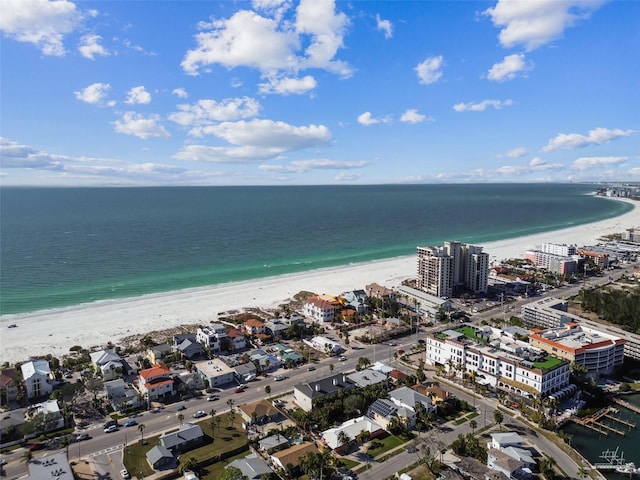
left=181, top=0, right=352, bottom=84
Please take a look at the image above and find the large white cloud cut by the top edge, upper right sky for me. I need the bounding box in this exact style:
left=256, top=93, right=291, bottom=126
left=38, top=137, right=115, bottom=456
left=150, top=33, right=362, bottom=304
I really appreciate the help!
left=484, top=0, right=604, bottom=51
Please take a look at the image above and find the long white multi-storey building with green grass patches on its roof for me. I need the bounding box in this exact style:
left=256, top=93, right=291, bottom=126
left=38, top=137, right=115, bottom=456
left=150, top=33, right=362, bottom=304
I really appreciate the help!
left=425, top=325, right=569, bottom=398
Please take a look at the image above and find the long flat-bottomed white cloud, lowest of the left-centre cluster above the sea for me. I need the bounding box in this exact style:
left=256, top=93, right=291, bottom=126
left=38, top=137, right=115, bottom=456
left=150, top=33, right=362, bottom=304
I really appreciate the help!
left=202, top=120, right=331, bottom=152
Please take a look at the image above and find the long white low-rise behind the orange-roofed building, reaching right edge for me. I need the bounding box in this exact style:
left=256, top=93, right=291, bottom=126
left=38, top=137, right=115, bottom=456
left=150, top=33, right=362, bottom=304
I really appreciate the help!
left=522, top=297, right=640, bottom=360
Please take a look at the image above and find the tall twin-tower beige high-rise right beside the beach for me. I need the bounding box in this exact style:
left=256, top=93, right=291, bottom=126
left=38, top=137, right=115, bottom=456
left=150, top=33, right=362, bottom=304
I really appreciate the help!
left=417, top=242, right=489, bottom=297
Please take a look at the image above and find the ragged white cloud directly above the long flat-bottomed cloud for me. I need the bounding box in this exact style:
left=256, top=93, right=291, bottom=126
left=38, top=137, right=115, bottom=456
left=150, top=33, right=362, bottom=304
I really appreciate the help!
left=169, top=97, right=260, bottom=130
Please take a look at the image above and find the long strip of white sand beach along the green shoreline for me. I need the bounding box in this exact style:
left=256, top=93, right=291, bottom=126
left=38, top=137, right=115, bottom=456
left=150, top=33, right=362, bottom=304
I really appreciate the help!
left=0, top=196, right=640, bottom=363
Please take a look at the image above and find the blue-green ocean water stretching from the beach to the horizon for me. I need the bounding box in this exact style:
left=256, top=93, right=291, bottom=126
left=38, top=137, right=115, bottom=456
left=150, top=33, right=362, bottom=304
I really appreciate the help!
left=0, top=184, right=632, bottom=315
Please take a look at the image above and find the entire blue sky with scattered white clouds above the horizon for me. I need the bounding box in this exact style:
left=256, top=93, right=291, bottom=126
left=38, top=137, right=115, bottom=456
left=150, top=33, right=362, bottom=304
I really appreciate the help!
left=0, top=0, right=640, bottom=186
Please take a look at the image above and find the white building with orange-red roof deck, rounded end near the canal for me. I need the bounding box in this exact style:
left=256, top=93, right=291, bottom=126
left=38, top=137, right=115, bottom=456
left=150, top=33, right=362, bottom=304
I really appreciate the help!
left=529, top=322, right=625, bottom=378
